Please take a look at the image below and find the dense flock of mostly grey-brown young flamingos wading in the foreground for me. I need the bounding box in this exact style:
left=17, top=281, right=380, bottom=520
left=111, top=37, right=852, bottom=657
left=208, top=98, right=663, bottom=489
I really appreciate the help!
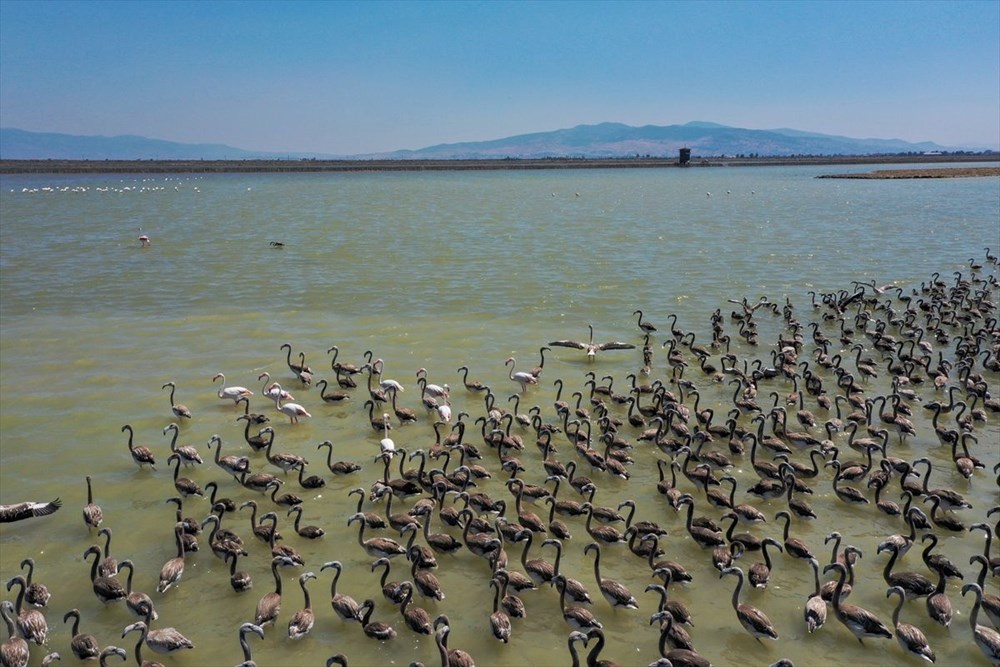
left=0, top=249, right=1000, bottom=667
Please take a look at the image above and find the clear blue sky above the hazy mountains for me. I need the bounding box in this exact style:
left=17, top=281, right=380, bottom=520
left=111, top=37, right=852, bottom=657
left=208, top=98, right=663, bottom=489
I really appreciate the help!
left=0, top=0, right=1000, bottom=154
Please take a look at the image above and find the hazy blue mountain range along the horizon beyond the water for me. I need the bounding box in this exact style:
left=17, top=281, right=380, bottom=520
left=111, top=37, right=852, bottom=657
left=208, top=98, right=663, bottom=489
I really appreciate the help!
left=0, top=121, right=982, bottom=160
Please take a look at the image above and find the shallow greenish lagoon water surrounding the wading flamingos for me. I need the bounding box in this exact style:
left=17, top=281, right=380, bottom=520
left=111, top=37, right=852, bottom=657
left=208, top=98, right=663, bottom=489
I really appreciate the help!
left=0, top=167, right=1000, bottom=665
